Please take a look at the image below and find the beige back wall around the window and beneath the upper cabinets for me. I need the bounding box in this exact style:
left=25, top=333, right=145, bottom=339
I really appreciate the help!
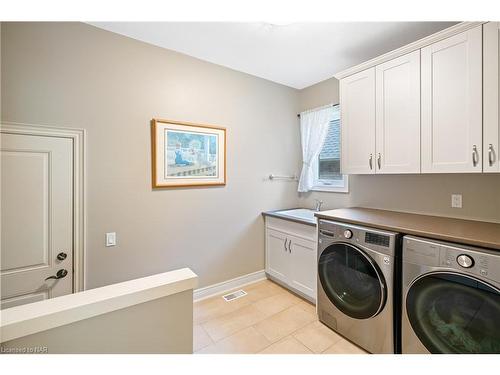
left=299, top=78, right=500, bottom=222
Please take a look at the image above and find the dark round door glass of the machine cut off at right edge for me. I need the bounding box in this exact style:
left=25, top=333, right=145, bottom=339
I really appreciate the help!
left=406, top=273, right=500, bottom=354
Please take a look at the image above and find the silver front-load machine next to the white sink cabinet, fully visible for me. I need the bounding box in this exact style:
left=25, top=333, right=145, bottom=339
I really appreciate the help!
left=317, top=220, right=401, bottom=353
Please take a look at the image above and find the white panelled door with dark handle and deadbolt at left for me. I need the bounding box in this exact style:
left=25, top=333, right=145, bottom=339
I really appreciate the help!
left=0, top=133, right=73, bottom=308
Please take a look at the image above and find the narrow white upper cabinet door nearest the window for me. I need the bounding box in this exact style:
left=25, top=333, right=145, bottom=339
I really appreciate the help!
left=340, top=68, right=375, bottom=174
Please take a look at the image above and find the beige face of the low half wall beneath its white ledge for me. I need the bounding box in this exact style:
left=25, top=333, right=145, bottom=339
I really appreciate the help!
left=1, top=290, right=193, bottom=354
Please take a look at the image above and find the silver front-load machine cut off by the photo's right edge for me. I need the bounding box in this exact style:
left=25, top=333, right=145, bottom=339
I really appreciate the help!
left=402, top=236, right=500, bottom=354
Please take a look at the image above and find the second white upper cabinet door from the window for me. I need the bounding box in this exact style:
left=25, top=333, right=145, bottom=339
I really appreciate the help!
left=375, top=51, right=420, bottom=173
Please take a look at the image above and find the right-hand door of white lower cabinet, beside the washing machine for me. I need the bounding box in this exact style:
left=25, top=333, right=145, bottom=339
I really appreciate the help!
left=289, top=237, right=317, bottom=300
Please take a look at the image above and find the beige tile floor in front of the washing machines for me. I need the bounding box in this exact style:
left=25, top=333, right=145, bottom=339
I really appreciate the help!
left=193, top=280, right=366, bottom=354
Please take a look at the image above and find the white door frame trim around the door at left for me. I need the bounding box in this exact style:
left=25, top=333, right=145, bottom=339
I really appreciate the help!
left=0, top=121, right=87, bottom=293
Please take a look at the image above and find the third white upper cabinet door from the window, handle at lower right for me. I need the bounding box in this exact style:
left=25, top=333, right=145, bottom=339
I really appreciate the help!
left=421, top=26, right=482, bottom=173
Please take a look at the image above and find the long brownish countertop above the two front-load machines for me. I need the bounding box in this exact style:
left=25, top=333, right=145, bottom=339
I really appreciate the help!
left=315, top=207, right=500, bottom=250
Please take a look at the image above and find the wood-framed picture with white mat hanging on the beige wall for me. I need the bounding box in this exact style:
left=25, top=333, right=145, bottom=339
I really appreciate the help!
left=151, top=119, right=226, bottom=188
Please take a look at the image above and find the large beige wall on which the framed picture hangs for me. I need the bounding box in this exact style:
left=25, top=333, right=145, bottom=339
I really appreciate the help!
left=1, top=23, right=300, bottom=288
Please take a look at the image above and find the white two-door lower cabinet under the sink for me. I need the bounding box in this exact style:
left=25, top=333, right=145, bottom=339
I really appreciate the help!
left=266, top=217, right=317, bottom=302
